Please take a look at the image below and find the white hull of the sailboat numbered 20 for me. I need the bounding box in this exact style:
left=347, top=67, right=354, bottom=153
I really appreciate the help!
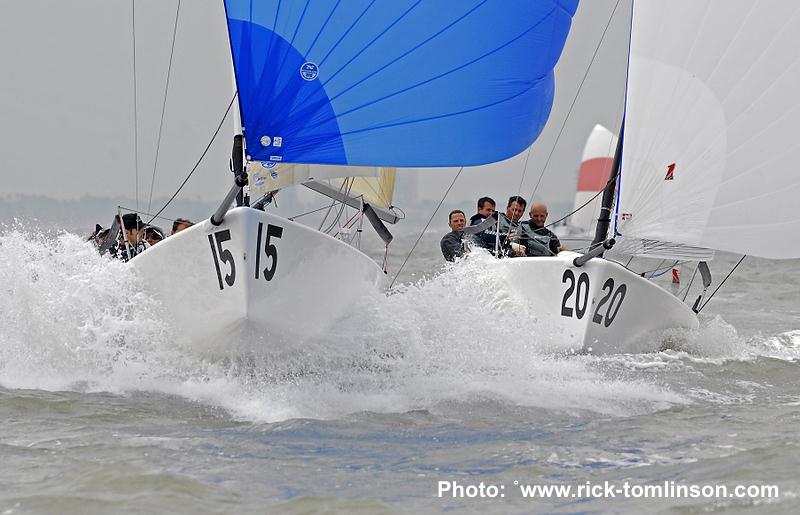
left=497, top=252, right=698, bottom=353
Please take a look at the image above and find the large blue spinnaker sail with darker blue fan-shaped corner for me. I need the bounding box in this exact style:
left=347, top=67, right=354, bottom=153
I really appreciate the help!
left=225, top=0, right=578, bottom=167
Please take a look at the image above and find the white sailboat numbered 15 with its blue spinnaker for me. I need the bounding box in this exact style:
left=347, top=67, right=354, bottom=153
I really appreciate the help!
left=125, top=0, right=577, bottom=352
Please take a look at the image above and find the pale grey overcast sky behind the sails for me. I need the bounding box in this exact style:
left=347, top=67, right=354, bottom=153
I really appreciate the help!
left=0, top=0, right=630, bottom=220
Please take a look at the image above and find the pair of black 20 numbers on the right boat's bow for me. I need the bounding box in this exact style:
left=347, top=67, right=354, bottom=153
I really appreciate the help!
left=561, top=269, right=628, bottom=327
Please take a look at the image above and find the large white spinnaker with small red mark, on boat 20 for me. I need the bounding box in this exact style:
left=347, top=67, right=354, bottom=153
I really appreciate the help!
left=616, top=0, right=800, bottom=258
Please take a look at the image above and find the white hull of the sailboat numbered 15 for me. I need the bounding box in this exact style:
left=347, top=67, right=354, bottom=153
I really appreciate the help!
left=131, top=208, right=386, bottom=353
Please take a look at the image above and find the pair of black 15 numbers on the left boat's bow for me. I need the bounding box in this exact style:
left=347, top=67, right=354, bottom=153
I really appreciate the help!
left=208, top=222, right=283, bottom=290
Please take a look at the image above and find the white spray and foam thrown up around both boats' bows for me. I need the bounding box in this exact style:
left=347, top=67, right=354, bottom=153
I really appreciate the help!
left=0, top=229, right=800, bottom=421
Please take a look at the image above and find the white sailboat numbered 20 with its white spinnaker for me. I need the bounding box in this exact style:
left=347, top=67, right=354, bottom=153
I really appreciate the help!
left=490, top=0, right=800, bottom=352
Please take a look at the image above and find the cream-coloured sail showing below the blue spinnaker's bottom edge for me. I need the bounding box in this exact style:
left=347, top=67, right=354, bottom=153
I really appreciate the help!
left=247, top=161, right=396, bottom=208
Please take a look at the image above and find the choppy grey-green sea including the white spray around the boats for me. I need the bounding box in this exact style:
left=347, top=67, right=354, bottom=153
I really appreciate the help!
left=0, top=227, right=800, bottom=513
